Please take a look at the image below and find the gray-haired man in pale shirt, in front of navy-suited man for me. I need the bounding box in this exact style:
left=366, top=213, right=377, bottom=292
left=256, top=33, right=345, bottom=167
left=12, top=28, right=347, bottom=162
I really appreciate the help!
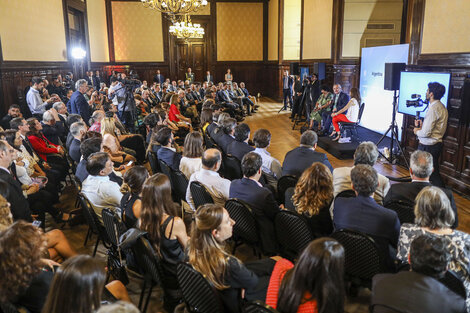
left=333, top=141, right=390, bottom=205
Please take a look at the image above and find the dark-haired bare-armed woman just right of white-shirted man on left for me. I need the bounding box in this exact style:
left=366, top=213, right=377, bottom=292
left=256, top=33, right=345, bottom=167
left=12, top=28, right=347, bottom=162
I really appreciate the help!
left=121, top=165, right=149, bottom=228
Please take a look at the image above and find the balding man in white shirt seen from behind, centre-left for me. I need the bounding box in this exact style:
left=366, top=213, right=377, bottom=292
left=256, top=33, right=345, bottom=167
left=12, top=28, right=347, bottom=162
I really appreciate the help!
left=186, top=149, right=230, bottom=210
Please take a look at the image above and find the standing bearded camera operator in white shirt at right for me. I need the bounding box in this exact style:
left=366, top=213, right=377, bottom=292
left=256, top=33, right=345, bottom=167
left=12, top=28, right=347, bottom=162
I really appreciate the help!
left=413, top=82, right=448, bottom=187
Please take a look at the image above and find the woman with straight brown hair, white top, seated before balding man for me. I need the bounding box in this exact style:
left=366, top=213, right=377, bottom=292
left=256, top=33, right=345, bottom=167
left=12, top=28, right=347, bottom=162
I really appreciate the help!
left=180, top=132, right=204, bottom=179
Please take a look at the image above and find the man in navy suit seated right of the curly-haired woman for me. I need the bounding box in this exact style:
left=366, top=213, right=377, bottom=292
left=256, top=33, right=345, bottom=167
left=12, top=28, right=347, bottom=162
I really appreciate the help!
left=333, top=164, right=400, bottom=269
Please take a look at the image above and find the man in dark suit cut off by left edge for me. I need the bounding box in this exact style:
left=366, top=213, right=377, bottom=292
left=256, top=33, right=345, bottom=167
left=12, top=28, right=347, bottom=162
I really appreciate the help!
left=0, top=140, right=32, bottom=222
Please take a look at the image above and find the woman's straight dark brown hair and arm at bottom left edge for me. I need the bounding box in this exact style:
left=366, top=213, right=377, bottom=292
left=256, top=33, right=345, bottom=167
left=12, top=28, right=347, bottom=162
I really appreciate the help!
left=42, top=255, right=130, bottom=313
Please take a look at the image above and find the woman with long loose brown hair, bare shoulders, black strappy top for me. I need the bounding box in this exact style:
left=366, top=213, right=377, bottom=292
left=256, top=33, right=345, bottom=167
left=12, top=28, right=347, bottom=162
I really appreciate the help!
left=139, top=173, right=189, bottom=312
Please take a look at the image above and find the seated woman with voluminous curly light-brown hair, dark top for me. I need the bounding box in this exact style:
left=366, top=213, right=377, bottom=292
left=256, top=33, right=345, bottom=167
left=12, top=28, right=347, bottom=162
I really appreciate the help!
left=292, top=162, right=333, bottom=237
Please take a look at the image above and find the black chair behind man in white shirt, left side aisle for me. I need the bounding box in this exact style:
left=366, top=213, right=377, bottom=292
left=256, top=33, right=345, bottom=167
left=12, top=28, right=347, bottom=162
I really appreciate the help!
left=78, top=192, right=110, bottom=256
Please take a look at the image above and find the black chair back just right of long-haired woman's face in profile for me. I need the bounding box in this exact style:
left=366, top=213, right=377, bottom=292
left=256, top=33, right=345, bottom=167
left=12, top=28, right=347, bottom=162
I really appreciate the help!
left=225, top=199, right=260, bottom=256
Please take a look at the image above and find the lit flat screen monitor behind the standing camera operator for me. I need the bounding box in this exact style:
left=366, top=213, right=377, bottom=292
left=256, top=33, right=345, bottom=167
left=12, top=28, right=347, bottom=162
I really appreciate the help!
left=398, top=72, right=450, bottom=117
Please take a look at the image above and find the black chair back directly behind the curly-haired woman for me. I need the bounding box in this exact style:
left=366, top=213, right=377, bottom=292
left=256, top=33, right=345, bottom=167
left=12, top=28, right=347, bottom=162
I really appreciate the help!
left=274, top=211, right=315, bottom=261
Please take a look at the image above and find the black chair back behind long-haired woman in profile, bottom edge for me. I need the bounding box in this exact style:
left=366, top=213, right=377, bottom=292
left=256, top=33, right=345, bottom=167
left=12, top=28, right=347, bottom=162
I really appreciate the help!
left=176, top=263, right=224, bottom=313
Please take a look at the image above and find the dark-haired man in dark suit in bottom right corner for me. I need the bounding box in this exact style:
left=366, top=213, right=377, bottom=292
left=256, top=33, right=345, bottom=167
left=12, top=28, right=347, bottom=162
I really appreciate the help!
left=371, top=234, right=467, bottom=313
